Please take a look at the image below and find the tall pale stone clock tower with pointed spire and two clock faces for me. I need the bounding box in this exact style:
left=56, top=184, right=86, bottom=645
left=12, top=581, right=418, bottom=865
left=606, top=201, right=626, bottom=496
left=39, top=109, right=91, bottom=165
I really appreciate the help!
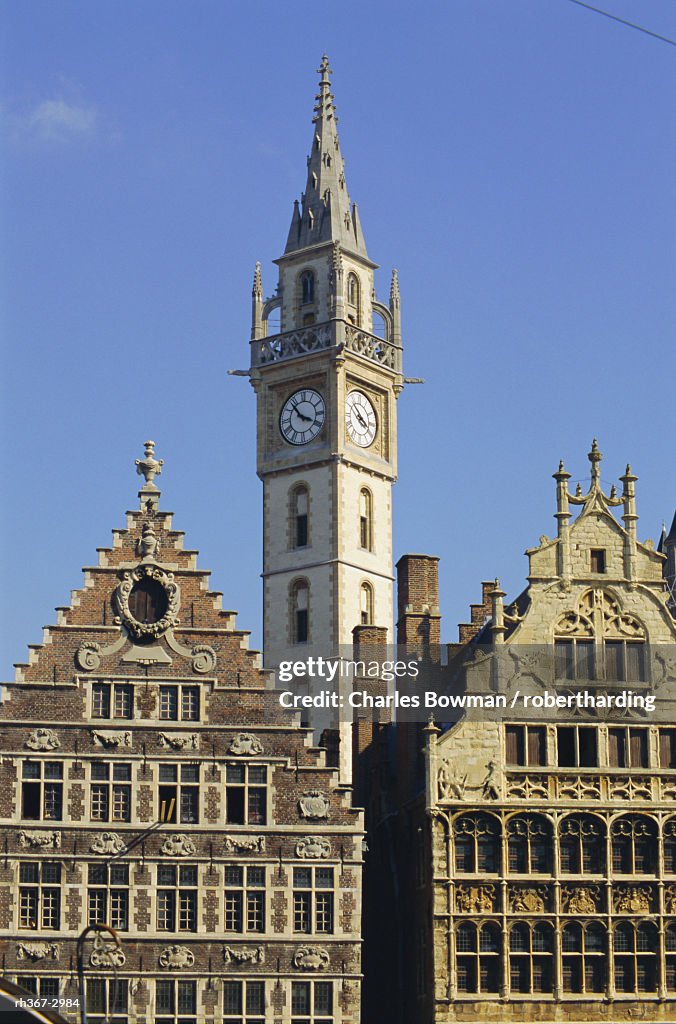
left=250, top=56, right=404, bottom=696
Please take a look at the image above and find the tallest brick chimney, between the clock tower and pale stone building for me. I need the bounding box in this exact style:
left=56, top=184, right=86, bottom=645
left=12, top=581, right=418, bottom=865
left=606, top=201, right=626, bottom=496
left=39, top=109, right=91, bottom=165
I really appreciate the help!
left=396, top=555, right=441, bottom=649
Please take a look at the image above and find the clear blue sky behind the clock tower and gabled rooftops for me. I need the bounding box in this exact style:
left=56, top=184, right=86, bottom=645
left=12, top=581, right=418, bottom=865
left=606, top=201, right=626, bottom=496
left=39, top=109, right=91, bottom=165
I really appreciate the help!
left=0, top=0, right=676, bottom=678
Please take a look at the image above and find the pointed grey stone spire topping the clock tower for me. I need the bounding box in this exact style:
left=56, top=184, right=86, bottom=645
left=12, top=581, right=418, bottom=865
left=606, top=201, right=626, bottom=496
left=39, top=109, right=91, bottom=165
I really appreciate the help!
left=285, top=54, right=368, bottom=259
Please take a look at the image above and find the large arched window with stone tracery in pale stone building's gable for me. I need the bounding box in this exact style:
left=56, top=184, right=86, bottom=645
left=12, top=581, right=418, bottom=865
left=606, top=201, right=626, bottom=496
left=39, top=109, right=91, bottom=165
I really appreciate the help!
left=554, top=590, right=647, bottom=682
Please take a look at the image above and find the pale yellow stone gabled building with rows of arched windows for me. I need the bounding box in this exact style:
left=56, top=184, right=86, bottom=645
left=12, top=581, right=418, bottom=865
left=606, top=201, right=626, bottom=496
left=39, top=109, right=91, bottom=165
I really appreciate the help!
left=396, top=442, right=676, bottom=1024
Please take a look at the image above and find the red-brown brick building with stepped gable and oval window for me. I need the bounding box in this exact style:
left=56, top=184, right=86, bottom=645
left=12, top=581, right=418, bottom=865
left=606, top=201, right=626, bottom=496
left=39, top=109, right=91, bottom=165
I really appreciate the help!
left=0, top=442, right=363, bottom=1024
